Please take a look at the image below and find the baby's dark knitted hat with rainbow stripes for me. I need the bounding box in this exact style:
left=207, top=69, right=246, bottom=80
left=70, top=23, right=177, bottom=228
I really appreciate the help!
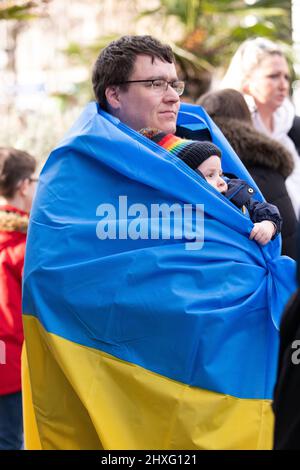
left=140, top=128, right=222, bottom=170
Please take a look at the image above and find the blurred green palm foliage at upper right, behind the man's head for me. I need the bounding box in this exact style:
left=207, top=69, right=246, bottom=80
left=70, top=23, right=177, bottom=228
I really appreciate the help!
left=142, top=0, right=291, bottom=99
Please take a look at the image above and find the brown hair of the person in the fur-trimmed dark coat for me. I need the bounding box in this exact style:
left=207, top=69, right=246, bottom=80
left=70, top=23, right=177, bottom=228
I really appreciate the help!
left=197, top=88, right=252, bottom=124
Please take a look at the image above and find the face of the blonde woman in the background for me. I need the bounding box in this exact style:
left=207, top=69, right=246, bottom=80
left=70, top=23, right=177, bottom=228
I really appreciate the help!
left=244, top=54, right=290, bottom=112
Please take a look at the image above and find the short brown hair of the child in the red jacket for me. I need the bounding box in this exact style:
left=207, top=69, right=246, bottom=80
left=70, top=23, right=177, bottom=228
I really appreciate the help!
left=0, top=147, right=36, bottom=199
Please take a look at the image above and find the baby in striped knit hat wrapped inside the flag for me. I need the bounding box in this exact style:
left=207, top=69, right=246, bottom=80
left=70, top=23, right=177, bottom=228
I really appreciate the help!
left=140, top=128, right=282, bottom=245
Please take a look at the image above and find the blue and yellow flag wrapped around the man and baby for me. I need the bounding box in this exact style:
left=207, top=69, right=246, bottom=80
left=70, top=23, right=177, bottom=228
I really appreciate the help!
left=23, top=103, right=295, bottom=449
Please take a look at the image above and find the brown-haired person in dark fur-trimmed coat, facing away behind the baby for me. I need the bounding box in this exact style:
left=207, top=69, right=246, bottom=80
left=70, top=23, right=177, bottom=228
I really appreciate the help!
left=198, top=89, right=297, bottom=259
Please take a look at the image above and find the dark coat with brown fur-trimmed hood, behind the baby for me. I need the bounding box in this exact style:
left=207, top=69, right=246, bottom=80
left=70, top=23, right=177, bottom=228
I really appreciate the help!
left=214, top=118, right=297, bottom=259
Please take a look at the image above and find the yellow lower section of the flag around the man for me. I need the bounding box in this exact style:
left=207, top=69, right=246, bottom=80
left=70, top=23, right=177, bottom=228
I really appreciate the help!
left=23, top=315, right=273, bottom=450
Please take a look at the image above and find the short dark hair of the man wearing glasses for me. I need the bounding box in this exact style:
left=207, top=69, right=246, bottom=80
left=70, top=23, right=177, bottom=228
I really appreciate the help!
left=92, top=36, right=175, bottom=110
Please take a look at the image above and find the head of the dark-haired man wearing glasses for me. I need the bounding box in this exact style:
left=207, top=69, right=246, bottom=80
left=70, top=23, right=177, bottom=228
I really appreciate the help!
left=92, top=36, right=184, bottom=133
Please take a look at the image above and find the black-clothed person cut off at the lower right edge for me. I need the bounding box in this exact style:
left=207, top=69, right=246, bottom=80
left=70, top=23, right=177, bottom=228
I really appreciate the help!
left=273, top=224, right=300, bottom=450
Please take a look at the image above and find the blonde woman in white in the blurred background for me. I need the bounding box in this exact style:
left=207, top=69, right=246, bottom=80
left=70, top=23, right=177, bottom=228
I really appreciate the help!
left=221, top=38, right=300, bottom=217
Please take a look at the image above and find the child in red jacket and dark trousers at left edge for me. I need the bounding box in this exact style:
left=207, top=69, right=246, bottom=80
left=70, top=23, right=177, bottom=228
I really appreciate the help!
left=0, top=147, right=37, bottom=450
